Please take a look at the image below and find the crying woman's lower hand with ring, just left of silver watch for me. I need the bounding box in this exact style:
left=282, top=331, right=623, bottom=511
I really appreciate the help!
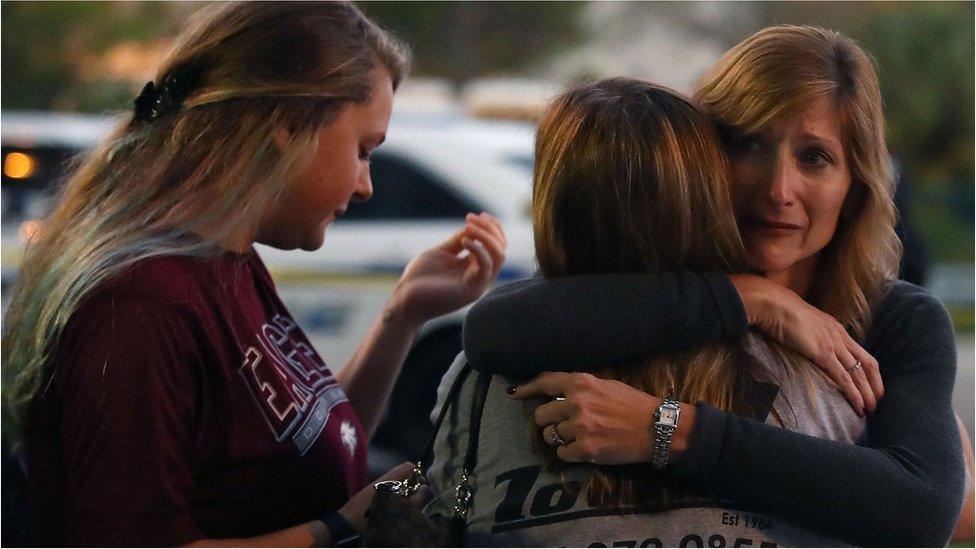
left=508, top=372, right=661, bottom=465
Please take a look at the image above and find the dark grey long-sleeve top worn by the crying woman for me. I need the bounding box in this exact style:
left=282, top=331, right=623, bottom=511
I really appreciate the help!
left=464, top=272, right=965, bottom=546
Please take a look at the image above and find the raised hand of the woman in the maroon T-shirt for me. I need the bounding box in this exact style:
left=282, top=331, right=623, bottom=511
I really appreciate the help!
left=392, top=213, right=508, bottom=323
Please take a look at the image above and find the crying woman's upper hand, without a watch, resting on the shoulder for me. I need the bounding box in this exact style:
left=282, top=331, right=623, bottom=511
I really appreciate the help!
left=729, top=274, right=884, bottom=416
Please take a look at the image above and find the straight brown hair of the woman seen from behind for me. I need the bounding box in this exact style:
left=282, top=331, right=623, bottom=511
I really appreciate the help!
left=533, top=78, right=772, bottom=506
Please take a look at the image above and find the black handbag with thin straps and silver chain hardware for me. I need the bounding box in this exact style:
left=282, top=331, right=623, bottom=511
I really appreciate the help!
left=363, top=364, right=492, bottom=547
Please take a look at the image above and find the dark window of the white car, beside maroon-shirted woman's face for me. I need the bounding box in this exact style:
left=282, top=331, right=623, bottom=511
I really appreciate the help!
left=342, top=152, right=477, bottom=222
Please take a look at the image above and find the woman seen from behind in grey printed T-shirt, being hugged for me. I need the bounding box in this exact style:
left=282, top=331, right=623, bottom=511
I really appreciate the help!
left=429, top=78, right=832, bottom=546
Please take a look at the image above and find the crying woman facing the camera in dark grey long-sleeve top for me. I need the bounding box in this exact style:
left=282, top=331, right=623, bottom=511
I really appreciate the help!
left=465, top=26, right=971, bottom=546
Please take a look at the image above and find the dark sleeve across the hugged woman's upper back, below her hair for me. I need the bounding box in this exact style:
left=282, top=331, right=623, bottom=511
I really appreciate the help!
left=464, top=271, right=749, bottom=377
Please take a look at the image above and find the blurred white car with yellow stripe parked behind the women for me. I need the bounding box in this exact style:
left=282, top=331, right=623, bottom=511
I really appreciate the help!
left=0, top=112, right=535, bottom=468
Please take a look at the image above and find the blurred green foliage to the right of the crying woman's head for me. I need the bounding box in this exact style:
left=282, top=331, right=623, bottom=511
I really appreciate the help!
left=863, top=2, right=976, bottom=262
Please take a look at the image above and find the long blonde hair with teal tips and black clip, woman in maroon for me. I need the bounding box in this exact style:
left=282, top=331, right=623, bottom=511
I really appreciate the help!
left=3, top=2, right=409, bottom=447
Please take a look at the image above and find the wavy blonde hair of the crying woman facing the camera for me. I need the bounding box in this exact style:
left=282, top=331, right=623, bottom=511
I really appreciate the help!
left=695, top=25, right=901, bottom=339
